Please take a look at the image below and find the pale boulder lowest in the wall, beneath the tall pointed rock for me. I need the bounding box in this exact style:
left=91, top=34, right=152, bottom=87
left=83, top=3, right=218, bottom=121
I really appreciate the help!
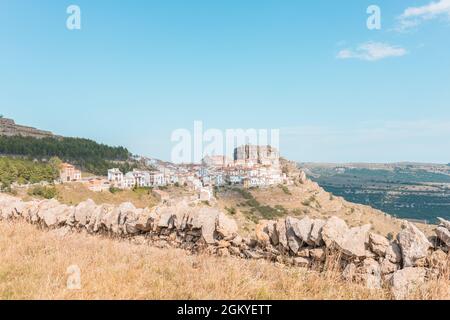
left=391, top=267, right=426, bottom=300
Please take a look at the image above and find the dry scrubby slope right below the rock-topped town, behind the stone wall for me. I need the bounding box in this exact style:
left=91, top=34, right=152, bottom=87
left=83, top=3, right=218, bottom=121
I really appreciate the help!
left=217, top=180, right=433, bottom=237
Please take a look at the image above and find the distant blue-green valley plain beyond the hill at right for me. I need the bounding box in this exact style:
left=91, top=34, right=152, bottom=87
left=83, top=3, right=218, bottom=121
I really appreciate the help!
left=299, top=163, right=450, bottom=223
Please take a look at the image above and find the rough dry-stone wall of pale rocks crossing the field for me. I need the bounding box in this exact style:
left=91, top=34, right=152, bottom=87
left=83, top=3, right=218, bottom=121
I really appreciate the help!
left=0, top=194, right=450, bottom=299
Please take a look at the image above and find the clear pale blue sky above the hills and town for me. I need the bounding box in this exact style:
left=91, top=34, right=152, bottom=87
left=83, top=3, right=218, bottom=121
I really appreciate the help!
left=0, top=0, right=450, bottom=163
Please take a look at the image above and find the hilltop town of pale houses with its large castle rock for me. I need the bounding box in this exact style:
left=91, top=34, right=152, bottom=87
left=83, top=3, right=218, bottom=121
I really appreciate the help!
left=60, top=145, right=292, bottom=201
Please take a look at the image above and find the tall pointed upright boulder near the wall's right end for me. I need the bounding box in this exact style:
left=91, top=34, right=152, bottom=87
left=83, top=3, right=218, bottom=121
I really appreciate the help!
left=398, top=221, right=432, bottom=268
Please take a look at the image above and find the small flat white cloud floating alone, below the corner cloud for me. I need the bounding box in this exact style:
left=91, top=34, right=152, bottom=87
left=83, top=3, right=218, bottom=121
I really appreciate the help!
left=337, top=42, right=408, bottom=61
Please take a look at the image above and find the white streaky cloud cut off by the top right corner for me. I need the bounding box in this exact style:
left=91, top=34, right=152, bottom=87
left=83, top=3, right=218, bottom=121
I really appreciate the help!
left=397, top=0, right=450, bottom=31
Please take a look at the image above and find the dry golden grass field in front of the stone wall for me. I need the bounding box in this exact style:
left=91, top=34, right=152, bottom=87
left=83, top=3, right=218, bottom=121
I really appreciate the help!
left=0, top=221, right=450, bottom=300
